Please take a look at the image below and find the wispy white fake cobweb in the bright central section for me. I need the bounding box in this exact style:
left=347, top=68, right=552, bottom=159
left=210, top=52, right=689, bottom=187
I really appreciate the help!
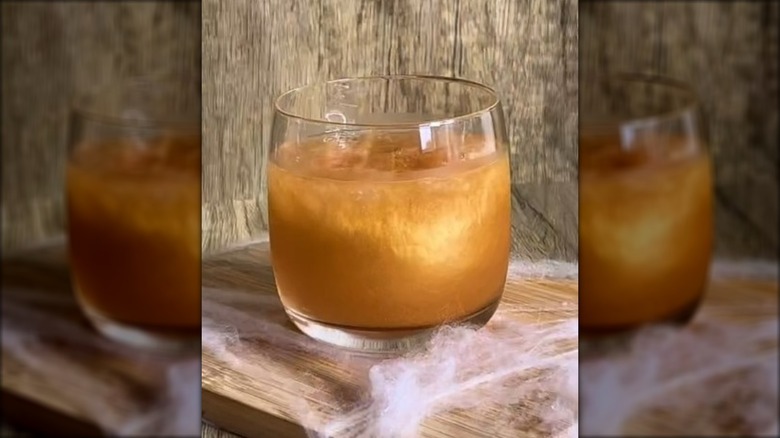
left=202, top=253, right=578, bottom=438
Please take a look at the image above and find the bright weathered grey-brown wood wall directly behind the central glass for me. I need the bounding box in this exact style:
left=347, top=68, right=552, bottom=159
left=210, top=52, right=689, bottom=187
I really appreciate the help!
left=203, top=0, right=577, bottom=259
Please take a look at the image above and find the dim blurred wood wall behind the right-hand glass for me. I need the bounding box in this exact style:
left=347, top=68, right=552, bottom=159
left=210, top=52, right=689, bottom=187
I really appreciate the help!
left=579, top=1, right=780, bottom=259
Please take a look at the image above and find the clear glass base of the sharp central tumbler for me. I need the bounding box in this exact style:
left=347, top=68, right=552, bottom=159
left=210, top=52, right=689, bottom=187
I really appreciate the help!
left=285, top=299, right=500, bottom=353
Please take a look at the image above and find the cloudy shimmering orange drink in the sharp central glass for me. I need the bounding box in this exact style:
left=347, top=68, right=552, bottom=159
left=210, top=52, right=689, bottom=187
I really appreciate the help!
left=268, top=134, right=510, bottom=330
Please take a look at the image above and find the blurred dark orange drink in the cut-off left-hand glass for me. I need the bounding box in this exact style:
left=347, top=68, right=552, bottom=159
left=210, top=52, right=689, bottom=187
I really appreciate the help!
left=67, top=133, right=201, bottom=332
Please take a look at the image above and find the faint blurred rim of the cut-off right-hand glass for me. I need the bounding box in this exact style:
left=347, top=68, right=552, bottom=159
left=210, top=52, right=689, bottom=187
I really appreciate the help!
left=586, top=72, right=700, bottom=127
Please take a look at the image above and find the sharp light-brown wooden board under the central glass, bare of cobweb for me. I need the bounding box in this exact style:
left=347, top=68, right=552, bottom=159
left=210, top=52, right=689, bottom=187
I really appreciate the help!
left=202, top=241, right=577, bottom=438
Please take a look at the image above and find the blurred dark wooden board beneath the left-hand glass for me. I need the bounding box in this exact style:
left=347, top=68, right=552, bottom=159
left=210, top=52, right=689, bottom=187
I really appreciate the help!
left=2, top=241, right=200, bottom=436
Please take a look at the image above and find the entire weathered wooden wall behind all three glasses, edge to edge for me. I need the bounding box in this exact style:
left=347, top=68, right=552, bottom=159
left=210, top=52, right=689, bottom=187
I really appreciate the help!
left=2, top=0, right=778, bottom=257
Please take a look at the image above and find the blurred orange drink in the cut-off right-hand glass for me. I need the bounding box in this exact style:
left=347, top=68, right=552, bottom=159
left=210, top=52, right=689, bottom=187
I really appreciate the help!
left=579, top=134, right=713, bottom=330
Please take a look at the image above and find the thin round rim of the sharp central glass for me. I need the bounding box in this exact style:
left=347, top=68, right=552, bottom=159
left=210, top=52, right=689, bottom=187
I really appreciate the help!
left=274, top=74, right=501, bottom=129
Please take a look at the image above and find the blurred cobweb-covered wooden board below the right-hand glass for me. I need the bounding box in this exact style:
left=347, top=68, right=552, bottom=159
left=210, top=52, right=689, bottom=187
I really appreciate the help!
left=579, top=272, right=778, bottom=437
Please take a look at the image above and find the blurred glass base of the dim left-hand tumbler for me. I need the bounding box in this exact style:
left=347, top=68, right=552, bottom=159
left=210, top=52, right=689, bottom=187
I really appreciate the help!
left=82, top=306, right=200, bottom=353
